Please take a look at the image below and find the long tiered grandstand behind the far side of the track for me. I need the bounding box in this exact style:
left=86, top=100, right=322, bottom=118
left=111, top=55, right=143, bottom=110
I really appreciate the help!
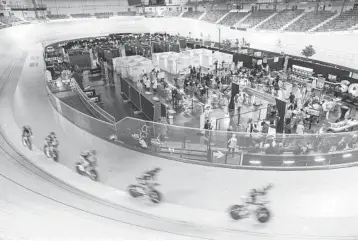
left=0, top=0, right=358, bottom=32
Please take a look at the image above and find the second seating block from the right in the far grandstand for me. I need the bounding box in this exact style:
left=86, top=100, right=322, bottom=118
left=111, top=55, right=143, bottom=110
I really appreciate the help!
left=285, top=11, right=335, bottom=32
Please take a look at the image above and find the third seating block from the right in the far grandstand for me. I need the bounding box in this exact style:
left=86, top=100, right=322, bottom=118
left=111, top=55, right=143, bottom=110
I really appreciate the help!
left=258, top=9, right=304, bottom=30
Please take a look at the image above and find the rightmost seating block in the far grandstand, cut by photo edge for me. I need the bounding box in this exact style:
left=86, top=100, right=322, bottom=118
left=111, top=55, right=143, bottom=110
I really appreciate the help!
left=316, top=9, right=358, bottom=32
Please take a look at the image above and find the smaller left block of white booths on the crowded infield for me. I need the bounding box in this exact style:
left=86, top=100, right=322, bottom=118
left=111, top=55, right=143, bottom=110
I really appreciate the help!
left=113, top=55, right=154, bottom=82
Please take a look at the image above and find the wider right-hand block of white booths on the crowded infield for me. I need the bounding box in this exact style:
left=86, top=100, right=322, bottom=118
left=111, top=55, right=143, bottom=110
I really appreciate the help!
left=152, top=49, right=233, bottom=74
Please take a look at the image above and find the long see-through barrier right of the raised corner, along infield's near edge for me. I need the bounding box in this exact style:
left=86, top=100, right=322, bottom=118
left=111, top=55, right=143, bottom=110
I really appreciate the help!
left=116, top=117, right=358, bottom=169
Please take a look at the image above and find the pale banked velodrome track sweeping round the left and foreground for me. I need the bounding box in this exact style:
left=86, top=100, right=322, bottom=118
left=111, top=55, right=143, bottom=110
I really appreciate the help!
left=0, top=23, right=358, bottom=239
